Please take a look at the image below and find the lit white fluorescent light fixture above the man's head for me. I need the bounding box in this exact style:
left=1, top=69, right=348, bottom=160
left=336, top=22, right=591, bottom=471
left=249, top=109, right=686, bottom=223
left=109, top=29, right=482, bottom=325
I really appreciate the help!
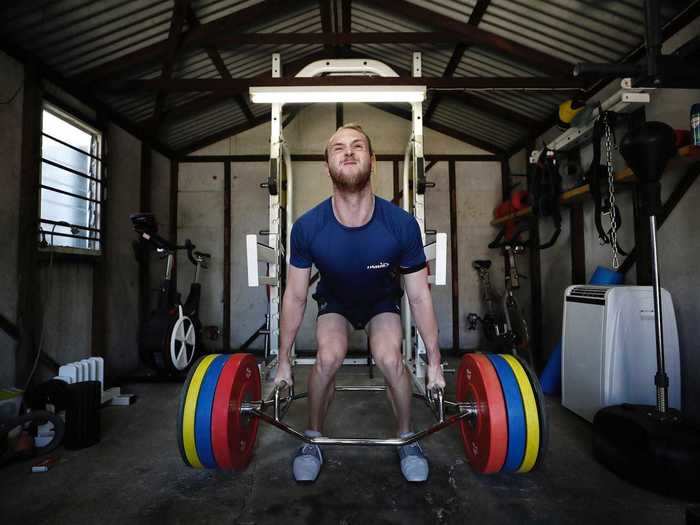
left=250, top=86, right=426, bottom=104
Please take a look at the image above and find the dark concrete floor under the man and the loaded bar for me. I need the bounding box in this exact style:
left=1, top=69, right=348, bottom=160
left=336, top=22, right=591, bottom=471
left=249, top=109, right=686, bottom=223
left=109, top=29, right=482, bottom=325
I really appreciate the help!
left=0, top=358, right=686, bottom=525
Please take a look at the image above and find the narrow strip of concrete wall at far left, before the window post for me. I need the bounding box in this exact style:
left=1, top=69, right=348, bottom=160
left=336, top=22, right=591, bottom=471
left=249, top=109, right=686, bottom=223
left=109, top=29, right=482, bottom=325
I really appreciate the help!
left=0, top=52, right=24, bottom=387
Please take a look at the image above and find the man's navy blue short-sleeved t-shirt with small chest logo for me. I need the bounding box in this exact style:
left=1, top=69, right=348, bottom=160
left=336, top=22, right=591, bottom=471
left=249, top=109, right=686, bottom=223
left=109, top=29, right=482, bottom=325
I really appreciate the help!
left=290, top=196, right=426, bottom=306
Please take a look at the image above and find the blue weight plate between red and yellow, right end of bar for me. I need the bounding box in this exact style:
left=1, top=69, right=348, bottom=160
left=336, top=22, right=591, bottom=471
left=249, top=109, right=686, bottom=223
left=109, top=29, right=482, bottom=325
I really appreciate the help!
left=488, top=354, right=527, bottom=472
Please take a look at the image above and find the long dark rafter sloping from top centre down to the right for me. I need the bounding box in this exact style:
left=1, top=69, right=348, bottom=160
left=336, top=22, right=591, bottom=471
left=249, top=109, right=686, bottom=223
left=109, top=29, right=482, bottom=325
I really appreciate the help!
left=365, top=0, right=573, bottom=76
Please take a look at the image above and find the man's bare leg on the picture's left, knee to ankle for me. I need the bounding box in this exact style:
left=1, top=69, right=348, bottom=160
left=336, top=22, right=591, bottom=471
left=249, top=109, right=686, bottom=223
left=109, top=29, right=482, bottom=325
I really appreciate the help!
left=308, top=314, right=348, bottom=432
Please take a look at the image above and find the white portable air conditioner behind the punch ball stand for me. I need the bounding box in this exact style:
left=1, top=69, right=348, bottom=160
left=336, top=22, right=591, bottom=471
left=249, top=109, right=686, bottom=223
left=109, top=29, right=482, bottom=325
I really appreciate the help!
left=562, top=285, right=681, bottom=421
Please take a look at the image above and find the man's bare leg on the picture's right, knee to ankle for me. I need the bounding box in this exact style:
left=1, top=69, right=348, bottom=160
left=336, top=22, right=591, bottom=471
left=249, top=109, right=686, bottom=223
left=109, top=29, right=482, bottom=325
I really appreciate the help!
left=367, top=312, right=412, bottom=434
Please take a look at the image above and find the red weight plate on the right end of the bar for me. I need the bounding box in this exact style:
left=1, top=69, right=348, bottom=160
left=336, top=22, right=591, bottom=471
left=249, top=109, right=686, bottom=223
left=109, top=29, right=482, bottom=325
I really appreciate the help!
left=457, top=354, right=508, bottom=474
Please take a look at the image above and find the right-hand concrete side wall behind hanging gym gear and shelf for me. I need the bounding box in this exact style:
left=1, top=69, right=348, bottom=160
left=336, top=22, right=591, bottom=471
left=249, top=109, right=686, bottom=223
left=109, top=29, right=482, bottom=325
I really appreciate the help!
left=511, top=20, right=700, bottom=418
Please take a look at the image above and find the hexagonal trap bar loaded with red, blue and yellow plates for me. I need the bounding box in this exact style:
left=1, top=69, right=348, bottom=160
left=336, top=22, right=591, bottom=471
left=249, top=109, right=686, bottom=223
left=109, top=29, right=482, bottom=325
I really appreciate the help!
left=177, top=353, right=548, bottom=474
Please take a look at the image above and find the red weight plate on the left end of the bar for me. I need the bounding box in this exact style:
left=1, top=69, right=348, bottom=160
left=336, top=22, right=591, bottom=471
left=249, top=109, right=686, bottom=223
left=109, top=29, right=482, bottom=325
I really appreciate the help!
left=211, top=354, right=261, bottom=470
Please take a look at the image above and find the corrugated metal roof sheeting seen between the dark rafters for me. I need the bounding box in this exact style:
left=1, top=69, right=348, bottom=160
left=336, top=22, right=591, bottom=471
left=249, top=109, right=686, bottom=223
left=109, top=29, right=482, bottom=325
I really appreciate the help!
left=0, top=0, right=683, bottom=154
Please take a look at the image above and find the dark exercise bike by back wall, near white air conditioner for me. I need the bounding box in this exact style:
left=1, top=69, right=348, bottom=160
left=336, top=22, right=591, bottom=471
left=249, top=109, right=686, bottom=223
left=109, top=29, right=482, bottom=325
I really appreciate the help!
left=467, top=225, right=534, bottom=369
